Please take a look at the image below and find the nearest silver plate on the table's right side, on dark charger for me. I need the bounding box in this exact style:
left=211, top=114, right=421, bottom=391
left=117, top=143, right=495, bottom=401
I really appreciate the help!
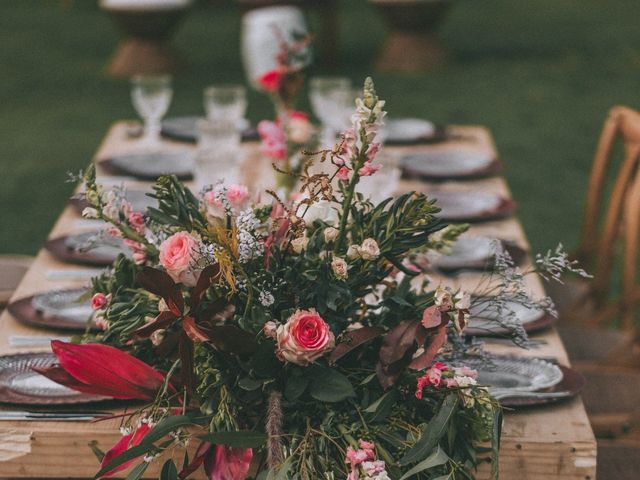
left=457, top=356, right=563, bottom=392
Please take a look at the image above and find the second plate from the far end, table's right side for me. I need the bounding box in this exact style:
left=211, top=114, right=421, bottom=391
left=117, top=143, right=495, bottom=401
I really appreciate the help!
left=400, top=148, right=502, bottom=180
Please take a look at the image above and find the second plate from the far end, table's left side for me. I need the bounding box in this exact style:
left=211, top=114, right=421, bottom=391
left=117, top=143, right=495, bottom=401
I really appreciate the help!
left=100, top=151, right=195, bottom=180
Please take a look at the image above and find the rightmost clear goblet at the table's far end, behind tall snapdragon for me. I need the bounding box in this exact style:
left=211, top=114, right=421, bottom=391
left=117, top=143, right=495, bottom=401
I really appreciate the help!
left=309, top=77, right=354, bottom=144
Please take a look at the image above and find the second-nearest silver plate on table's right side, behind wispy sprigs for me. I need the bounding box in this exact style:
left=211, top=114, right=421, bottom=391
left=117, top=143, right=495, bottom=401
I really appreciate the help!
left=468, top=300, right=545, bottom=333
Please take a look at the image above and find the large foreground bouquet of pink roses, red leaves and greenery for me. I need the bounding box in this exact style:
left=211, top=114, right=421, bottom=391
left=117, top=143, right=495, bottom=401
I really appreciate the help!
left=42, top=79, right=580, bottom=480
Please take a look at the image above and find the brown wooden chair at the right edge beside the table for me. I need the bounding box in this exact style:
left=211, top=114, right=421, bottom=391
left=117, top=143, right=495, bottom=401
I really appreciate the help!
left=549, top=106, right=640, bottom=365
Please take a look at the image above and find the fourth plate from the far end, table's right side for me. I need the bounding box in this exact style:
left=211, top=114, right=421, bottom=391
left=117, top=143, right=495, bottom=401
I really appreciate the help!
left=416, top=235, right=527, bottom=273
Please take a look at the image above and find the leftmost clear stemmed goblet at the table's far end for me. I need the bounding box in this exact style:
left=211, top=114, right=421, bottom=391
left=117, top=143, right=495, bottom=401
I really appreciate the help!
left=131, top=75, right=173, bottom=145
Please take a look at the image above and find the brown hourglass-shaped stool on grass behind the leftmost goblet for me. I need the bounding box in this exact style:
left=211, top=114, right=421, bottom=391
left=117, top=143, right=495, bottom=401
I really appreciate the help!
left=100, top=0, right=191, bottom=77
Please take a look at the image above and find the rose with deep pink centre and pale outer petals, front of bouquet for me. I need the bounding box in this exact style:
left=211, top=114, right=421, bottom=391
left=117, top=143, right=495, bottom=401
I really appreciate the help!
left=276, top=309, right=335, bottom=366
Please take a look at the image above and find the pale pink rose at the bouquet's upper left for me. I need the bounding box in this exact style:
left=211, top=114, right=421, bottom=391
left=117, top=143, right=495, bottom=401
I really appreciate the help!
left=160, top=232, right=199, bottom=287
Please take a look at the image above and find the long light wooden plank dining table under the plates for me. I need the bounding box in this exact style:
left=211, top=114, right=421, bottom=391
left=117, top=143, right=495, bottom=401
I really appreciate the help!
left=0, top=122, right=596, bottom=480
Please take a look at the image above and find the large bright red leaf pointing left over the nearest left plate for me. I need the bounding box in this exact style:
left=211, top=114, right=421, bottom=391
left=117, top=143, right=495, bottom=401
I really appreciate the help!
left=51, top=340, right=164, bottom=401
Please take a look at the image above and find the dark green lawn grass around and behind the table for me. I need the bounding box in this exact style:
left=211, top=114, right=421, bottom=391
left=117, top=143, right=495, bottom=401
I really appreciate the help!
left=0, top=0, right=640, bottom=253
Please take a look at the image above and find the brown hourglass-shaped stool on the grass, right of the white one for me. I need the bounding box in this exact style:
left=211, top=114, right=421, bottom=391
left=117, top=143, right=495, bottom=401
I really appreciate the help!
left=370, top=0, right=453, bottom=72
